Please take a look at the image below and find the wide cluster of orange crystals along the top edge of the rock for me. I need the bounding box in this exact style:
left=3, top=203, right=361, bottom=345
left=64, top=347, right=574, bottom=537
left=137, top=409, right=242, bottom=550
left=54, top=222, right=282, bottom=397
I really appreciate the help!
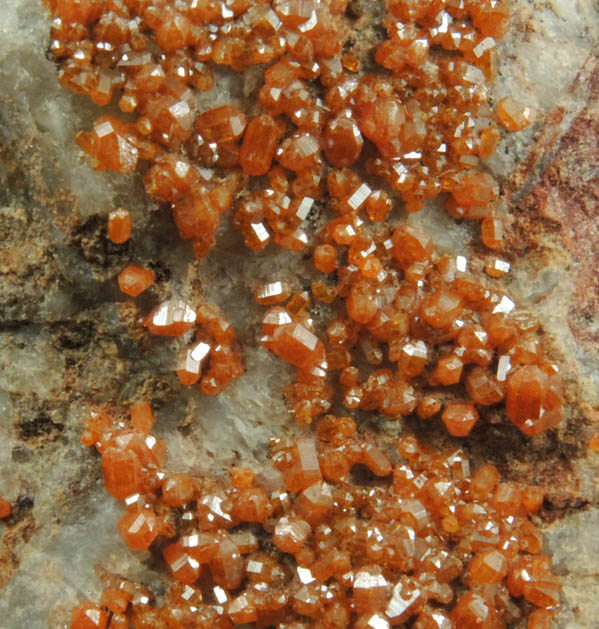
left=45, top=0, right=534, bottom=258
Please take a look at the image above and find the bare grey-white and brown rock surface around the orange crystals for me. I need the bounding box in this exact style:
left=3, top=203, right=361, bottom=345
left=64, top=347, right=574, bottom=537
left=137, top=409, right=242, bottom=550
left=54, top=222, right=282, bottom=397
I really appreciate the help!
left=0, top=0, right=599, bottom=629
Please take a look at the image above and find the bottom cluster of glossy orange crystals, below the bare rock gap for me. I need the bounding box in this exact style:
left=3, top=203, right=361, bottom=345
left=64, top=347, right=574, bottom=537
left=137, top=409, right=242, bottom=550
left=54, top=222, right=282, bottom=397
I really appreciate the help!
left=76, top=403, right=560, bottom=629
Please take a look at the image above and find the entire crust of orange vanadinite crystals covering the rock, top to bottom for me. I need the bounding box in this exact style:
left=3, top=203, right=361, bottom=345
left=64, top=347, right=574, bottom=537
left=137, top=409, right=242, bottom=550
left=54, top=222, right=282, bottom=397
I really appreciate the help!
left=42, top=0, right=564, bottom=629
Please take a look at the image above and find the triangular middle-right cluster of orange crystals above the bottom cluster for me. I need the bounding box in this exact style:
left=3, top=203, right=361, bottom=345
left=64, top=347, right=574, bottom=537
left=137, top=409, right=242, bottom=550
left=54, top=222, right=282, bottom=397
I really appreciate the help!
left=262, top=224, right=564, bottom=437
